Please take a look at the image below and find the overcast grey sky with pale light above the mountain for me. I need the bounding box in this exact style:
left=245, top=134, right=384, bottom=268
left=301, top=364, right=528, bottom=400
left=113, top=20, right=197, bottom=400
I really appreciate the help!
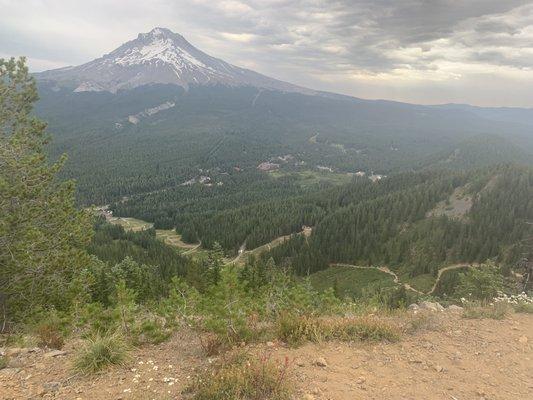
left=0, top=0, right=533, bottom=107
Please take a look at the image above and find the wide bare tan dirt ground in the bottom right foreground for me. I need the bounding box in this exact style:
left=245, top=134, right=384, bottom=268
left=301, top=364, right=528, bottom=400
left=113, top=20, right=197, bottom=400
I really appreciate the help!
left=275, top=312, right=533, bottom=400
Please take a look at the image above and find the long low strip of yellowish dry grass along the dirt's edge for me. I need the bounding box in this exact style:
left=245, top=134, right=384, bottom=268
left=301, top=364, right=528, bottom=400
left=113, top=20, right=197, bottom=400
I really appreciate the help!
left=277, top=314, right=400, bottom=345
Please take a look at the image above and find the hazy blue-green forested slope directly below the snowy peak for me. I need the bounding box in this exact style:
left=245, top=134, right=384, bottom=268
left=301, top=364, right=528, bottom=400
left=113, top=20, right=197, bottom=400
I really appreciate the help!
left=36, top=82, right=533, bottom=205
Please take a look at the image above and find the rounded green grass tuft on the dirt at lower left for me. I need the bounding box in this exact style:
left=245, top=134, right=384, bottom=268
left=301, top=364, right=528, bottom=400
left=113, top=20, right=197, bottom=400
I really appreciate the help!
left=74, top=334, right=129, bottom=374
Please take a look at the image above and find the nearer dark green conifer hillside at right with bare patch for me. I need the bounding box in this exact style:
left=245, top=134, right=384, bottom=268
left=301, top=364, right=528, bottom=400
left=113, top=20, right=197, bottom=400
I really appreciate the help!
left=264, top=166, right=533, bottom=276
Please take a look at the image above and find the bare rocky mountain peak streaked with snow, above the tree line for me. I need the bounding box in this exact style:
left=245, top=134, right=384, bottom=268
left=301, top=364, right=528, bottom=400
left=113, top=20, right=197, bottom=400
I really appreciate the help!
left=35, top=28, right=312, bottom=93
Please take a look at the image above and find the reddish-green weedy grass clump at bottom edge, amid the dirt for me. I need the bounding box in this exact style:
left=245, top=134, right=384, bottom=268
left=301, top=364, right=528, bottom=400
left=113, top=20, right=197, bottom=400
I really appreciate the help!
left=189, top=354, right=293, bottom=400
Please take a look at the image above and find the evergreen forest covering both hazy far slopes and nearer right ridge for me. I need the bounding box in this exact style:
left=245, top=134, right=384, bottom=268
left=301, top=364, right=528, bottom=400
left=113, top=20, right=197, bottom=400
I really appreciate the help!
left=36, top=82, right=533, bottom=288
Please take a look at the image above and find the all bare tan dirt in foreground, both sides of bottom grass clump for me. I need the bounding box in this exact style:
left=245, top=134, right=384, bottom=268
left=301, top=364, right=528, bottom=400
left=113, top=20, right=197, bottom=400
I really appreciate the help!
left=0, top=311, right=533, bottom=400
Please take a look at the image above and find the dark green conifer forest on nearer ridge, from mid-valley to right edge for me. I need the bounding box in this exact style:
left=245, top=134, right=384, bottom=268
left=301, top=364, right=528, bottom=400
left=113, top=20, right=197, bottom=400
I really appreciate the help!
left=109, top=164, right=533, bottom=282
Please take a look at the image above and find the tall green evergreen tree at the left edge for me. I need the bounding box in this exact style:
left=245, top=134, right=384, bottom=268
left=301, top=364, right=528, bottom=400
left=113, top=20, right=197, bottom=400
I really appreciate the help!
left=0, top=58, right=91, bottom=326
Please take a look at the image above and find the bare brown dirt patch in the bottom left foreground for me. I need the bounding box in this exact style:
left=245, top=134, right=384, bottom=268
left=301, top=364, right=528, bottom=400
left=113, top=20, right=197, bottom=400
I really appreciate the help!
left=0, top=330, right=208, bottom=400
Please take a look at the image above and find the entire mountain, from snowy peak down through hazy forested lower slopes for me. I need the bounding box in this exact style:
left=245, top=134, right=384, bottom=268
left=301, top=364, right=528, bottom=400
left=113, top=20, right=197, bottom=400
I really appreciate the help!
left=31, top=28, right=533, bottom=204
